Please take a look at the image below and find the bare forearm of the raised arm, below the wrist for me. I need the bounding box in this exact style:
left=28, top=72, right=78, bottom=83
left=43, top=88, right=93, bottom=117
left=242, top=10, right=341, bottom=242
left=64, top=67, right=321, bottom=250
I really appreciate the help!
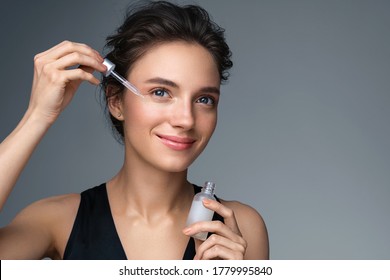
left=0, top=111, right=50, bottom=209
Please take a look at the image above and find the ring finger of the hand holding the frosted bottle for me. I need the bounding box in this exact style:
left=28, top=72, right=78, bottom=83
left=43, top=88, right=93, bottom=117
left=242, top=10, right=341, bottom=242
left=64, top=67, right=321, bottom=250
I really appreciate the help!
left=195, top=234, right=246, bottom=259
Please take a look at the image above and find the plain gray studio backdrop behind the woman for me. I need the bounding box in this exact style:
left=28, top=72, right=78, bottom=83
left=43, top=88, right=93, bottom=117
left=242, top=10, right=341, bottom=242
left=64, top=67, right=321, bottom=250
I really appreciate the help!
left=0, top=0, right=390, bottom=259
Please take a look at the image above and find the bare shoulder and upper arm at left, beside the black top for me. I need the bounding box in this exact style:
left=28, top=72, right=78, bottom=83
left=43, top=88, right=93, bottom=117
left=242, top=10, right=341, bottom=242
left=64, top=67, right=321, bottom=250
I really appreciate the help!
left=0, top=194, right=80, bottom=259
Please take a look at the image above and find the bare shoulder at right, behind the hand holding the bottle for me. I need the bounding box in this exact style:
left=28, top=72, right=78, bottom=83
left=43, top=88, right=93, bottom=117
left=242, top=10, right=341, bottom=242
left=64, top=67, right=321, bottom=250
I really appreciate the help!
left=221, top=199, right=269, bottom=259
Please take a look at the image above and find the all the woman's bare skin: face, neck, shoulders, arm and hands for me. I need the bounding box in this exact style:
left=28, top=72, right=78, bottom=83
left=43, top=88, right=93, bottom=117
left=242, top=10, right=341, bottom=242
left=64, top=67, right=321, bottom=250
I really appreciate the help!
left=0, top=42, right=268, bottom=259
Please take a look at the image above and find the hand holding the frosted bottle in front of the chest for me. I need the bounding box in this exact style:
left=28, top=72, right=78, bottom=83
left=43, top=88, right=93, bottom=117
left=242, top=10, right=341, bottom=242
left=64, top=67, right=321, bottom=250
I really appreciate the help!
left=183, top=199, right=247, bottom=260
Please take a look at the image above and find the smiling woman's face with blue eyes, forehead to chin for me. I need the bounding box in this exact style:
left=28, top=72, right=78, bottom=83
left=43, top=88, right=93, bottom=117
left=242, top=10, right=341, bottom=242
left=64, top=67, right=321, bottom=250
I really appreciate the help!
left=116, top=42, right=220, bottom=172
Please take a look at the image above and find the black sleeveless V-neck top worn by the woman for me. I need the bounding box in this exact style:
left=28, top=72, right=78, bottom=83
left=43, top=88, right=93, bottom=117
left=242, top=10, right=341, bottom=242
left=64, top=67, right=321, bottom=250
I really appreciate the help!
left=63, top=183, right=223, bottom=260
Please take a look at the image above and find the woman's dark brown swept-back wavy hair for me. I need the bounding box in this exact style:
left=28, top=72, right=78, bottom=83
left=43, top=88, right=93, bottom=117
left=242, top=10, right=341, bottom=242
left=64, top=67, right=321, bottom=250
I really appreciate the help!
left=102, top=1, right=233, bottom=140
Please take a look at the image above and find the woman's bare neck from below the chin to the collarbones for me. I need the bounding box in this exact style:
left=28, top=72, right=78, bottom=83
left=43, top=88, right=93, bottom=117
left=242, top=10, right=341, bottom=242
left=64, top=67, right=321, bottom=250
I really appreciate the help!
left=107, top=153, right=194, bottom=219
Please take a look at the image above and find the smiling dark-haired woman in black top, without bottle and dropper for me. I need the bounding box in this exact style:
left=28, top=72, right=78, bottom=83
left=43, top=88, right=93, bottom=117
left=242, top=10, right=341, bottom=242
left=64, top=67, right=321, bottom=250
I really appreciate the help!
left=0, top=2, right=268, bottom=259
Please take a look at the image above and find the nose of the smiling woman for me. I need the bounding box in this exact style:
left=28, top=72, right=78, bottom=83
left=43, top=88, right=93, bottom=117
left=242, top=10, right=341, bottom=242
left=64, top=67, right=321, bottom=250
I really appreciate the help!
left=170, top=100, right=195, bottom=130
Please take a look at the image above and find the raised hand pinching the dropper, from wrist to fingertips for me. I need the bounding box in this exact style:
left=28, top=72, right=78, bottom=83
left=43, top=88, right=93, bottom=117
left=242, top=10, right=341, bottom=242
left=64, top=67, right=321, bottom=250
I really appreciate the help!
left=28, top=41, right=106, bottom=124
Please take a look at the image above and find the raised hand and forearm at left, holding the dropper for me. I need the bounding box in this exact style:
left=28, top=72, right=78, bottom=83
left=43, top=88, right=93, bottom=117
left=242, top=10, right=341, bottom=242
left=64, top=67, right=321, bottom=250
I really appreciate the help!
left=0, top=41, right=106, bottom=210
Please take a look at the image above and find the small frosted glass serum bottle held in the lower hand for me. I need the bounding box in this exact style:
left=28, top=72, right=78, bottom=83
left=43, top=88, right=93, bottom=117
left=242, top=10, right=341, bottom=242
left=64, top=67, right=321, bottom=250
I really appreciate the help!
left=186, top=181, right=215, bottom=240
